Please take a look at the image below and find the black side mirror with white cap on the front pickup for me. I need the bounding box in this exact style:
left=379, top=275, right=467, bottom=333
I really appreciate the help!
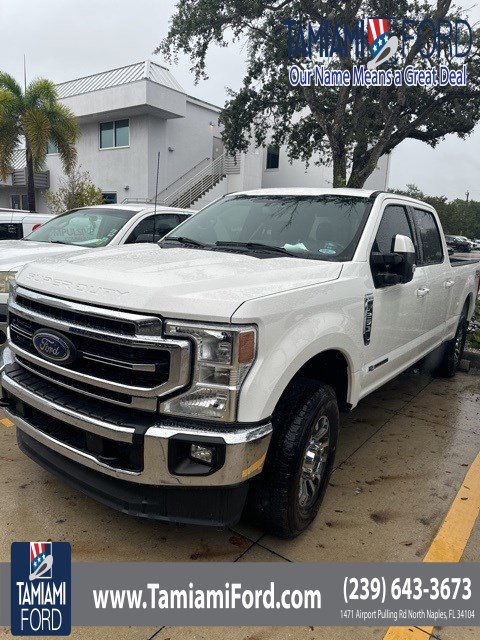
left=371, top=234, right=416, bottom=287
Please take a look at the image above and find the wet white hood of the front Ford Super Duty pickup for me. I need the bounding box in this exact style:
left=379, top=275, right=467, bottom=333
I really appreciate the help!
left=17, top=244, right=342, bottom=322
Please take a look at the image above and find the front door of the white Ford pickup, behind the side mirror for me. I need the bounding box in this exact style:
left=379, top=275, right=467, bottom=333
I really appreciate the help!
left=362, top=204, right=427, bottom=395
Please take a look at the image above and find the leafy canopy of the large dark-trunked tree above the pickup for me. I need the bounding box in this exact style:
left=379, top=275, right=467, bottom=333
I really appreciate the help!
left=156, top=0, right=480, bottom=187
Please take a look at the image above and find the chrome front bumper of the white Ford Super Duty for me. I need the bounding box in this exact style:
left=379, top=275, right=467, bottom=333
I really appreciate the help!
left=0, top=349, right=272, bottom=487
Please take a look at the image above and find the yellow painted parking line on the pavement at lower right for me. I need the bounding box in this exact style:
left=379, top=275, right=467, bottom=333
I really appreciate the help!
left=383, top=453, right=480, bottom=640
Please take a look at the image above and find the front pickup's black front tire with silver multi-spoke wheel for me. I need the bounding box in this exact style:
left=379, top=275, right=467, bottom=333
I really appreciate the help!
left=246, top=379, right=339, bottom=538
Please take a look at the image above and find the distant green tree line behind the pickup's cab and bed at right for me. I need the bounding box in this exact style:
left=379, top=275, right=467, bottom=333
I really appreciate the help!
left=395, top=184, right=480, bottom=238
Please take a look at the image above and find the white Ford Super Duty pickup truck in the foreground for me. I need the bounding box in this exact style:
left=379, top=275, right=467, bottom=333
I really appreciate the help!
left=1, top=189, right=480, bottom=537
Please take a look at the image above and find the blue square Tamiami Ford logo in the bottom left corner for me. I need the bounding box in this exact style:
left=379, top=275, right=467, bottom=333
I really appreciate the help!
left=10, top=542, right=71, bottom=636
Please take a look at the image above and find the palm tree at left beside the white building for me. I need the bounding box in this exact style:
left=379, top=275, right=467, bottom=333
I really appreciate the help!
left=0, top=72, right=79, bottom=211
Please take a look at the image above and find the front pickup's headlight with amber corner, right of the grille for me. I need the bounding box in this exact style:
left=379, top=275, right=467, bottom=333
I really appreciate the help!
left=160, top=320, right=257, bottom=422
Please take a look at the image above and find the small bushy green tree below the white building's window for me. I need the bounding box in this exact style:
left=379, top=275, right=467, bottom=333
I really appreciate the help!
left=45, top=169, right=103, bottom=213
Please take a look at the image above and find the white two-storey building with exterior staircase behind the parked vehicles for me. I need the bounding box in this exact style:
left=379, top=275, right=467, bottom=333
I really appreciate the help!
left=0, top=61, right=388, bottom=211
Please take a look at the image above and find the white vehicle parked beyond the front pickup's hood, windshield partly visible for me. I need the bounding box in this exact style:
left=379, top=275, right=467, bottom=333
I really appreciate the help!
left=0, top=204, right=193, bottom=351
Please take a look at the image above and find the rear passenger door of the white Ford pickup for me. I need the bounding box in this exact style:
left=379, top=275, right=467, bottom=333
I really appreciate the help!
left=412, top=207, right=455, bottom=349
